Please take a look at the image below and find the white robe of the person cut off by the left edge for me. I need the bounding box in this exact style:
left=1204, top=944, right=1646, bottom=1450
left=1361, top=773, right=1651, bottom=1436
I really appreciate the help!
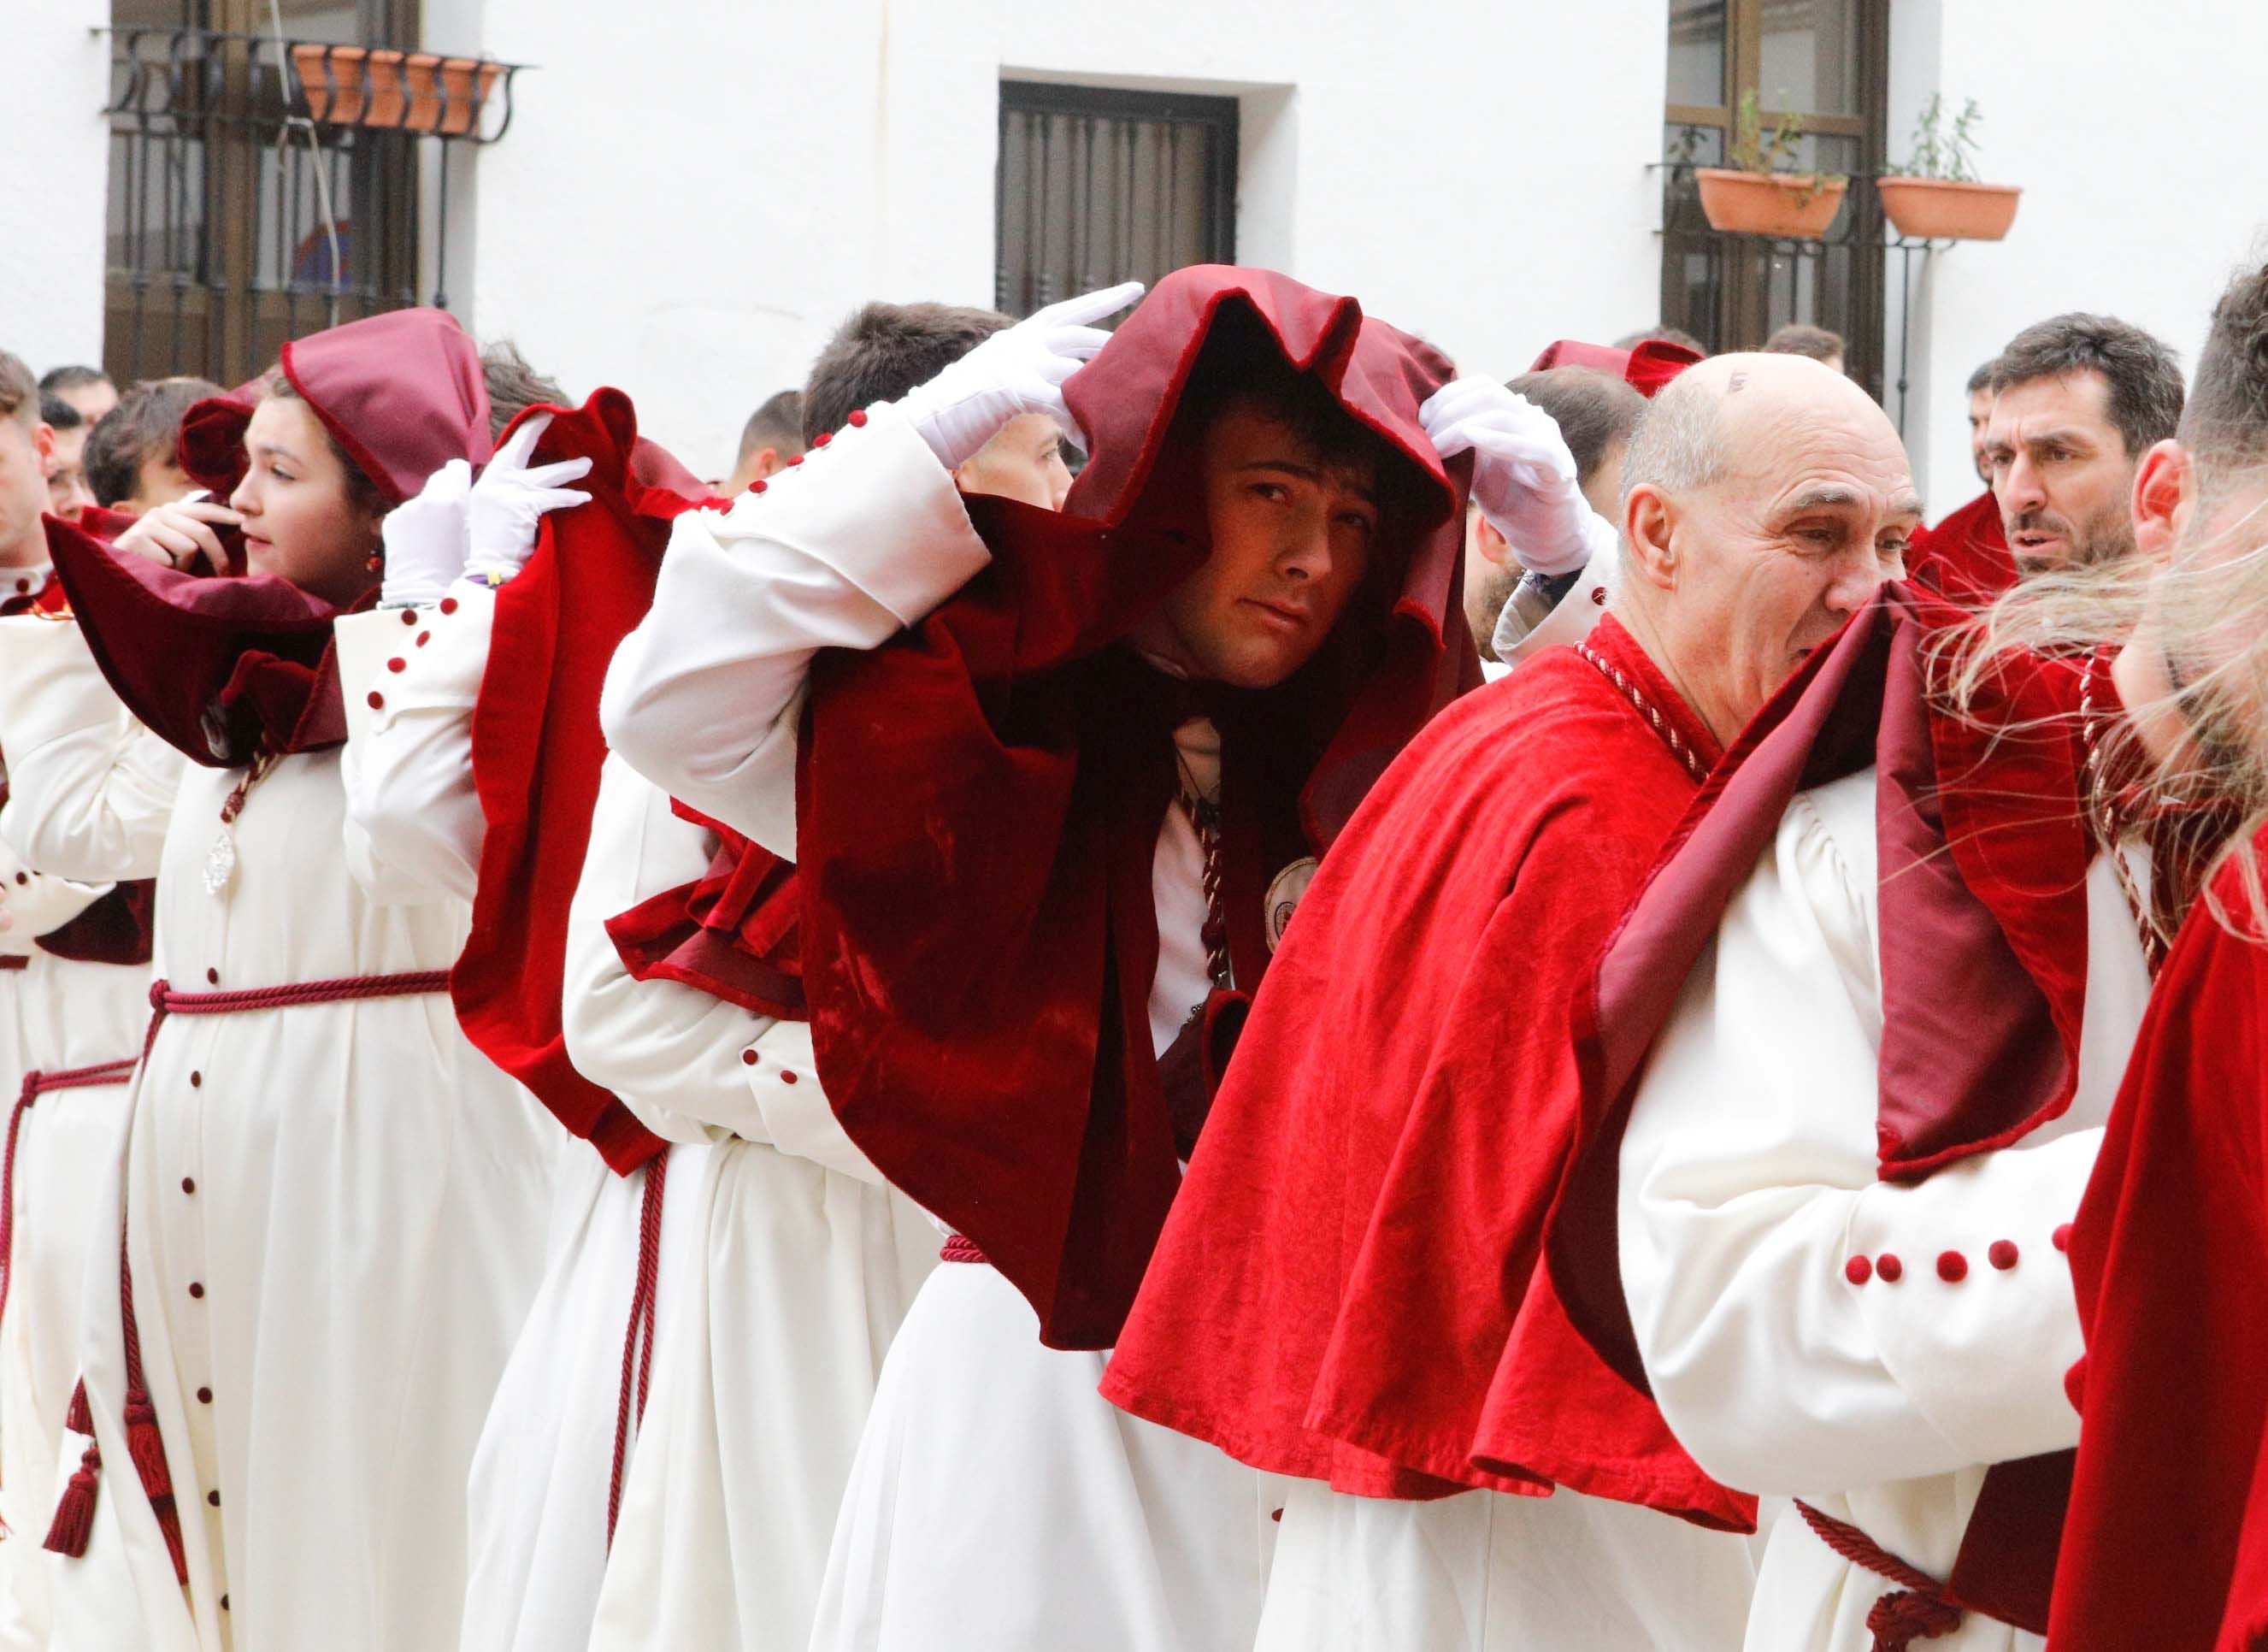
left=0, top=826, right=150, bottom=1652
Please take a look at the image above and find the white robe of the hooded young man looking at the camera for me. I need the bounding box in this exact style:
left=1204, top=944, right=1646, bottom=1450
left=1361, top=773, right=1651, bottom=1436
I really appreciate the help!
left=601, top=406, right=1275, bottom=1652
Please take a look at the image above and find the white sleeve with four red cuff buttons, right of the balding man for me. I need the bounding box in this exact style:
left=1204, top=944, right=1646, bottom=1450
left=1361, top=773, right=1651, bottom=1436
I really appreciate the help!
left=1619, top=770, right=2102, bottom=1496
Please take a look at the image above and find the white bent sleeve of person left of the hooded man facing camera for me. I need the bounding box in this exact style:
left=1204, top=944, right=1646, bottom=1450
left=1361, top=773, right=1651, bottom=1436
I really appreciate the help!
left=565, top=756, right=882, bottom=1183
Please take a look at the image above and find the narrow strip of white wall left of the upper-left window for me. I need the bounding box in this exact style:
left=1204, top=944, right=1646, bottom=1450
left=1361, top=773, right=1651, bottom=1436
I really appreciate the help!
left=0, top=0, right=111, bottom=372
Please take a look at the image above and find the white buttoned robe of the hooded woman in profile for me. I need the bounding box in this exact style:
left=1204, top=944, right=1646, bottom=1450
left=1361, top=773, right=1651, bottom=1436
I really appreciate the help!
left=0, top=626, right=551, bottom=1652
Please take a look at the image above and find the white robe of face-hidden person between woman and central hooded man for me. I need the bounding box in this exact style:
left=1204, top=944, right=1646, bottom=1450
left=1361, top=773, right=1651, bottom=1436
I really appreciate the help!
left=567, top=758, right=937, bottom=1652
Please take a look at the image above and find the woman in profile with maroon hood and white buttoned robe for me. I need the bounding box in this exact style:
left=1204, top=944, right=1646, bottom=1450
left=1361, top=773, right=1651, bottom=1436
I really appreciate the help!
left=0, top=311, right=549, bottom=1652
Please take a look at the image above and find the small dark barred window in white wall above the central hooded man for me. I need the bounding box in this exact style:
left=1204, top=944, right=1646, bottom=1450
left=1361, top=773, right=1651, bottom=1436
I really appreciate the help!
left=993, top=80, right=1236, bottom=316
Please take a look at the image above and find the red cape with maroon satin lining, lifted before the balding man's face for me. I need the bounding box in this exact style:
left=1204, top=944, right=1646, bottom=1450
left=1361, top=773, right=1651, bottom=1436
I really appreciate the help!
left=1546, top=583, right=2116, bottom=1631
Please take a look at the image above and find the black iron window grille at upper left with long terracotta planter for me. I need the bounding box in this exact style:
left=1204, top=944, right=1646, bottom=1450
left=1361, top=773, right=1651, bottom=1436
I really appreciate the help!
left=97, top=27, right=528, bottom=384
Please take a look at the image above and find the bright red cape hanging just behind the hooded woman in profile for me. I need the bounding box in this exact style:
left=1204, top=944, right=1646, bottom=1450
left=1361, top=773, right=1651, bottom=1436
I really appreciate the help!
left=449, top=390, right=708, bottom=1173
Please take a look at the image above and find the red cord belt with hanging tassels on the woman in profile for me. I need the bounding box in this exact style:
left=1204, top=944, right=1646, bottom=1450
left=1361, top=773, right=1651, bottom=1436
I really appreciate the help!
left=45, top=969, right=449, bottom=1584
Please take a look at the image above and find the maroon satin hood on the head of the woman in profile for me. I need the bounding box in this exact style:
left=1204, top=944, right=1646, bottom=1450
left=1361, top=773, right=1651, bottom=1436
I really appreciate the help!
left=181, top=309, right=494, bottom=506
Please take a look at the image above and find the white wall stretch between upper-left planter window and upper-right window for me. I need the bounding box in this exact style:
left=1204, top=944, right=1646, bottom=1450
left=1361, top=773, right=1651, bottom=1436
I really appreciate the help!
left=456, top=0, right=1667, bottom=475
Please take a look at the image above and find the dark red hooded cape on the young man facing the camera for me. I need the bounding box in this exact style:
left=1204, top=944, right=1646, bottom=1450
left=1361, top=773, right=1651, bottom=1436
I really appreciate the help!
left=796, top=266, right=1479, bottom=1348
